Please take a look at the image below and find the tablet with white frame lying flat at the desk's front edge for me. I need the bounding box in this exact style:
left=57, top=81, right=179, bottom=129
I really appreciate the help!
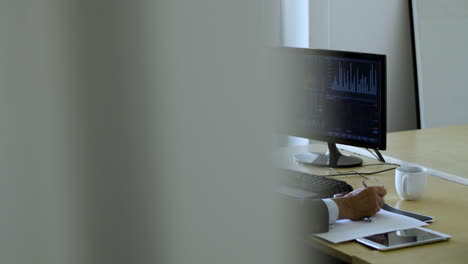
left=356, top=227, right=450, bottom=250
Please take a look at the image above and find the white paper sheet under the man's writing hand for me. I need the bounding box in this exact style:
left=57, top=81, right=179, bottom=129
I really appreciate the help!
left=316, top=209, right=427, bottom=243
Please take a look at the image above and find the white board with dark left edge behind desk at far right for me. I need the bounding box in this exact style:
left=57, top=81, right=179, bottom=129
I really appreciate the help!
left=412, top=0, right=468, bottom=128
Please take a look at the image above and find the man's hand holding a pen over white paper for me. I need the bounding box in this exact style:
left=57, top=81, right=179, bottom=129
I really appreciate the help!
left=333, top=186, right=387, bottom=220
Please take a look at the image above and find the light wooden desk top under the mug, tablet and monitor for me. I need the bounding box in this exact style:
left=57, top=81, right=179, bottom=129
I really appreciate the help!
left=283, top=126, right=468, bottom=264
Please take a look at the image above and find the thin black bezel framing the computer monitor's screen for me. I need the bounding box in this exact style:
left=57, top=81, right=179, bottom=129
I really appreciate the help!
left=286, top=47, right=387, bottom=150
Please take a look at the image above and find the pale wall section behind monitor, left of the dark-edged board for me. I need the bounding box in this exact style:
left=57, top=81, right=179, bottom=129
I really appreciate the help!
left=310, top=0, right=417, bottom=131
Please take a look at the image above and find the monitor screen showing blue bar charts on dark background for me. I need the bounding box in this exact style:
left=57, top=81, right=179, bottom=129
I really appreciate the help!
left=296, top=55, right=383, bottom=143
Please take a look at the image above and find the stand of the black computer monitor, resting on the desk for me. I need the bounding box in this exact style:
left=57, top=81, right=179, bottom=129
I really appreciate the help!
left=294, top=142, right=362, bottom=168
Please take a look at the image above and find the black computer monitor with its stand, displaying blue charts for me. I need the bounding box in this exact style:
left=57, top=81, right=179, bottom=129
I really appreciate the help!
left=282, top=47, right=386, bottom=168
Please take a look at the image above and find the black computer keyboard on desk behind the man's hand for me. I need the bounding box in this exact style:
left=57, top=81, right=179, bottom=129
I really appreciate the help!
left=278, top=169, right=353, bottom=198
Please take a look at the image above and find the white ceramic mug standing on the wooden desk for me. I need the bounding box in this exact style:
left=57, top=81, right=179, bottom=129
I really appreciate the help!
left=395, top=166, right=427, bottom=200
